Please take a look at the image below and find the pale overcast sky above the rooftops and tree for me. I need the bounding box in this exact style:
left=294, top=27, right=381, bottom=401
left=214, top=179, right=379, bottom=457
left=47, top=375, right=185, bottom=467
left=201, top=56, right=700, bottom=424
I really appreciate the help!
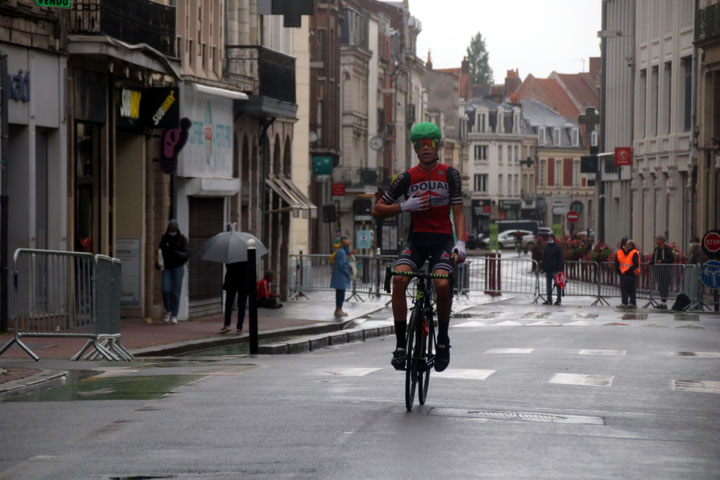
left=410, top=0, right=602, bottom=83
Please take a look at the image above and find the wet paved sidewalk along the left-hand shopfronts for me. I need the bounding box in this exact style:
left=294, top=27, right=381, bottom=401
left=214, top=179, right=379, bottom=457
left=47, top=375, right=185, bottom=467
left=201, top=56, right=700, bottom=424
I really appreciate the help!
left=0, top=291, right=389, bottom=384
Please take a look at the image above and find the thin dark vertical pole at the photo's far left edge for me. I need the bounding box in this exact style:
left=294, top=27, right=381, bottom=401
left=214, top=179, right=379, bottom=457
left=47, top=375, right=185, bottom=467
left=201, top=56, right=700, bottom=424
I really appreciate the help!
left=0, top=52, right=10, bottom=332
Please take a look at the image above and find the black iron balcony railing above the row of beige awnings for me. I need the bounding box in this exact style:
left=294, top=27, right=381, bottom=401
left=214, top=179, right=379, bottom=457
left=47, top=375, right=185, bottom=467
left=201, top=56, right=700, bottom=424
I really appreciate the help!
left=225, top=45, right=295, bottom=103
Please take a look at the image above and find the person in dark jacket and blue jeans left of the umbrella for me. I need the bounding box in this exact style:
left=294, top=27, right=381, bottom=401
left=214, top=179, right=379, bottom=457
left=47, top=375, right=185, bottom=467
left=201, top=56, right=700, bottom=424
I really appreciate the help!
left=158, top=219, right=188, bottom=325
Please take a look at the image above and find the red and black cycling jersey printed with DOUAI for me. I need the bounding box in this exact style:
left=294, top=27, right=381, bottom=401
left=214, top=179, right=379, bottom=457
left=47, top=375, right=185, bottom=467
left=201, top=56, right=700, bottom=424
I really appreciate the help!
left=382, top=163, right=462, bottom=240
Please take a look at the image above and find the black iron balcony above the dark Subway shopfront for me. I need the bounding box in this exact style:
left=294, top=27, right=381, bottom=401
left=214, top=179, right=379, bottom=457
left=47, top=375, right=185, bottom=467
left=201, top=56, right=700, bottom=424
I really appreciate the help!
left=68, top=0, right=176, bottom=57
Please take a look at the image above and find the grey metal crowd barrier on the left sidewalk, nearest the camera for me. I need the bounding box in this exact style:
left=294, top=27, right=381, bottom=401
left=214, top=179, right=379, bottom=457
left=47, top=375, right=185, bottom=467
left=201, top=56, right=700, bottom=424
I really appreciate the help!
left=0, top=249, right=132, bottom=361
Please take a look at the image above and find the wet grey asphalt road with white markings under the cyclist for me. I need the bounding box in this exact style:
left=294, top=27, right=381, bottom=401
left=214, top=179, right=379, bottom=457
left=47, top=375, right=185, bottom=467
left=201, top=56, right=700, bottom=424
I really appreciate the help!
left=0, top=299, right=720, bottom=479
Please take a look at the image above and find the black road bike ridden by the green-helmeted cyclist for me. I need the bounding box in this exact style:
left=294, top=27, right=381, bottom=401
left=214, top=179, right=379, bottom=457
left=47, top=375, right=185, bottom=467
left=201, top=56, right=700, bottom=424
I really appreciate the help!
left=385, top=267, right=454, bottom=412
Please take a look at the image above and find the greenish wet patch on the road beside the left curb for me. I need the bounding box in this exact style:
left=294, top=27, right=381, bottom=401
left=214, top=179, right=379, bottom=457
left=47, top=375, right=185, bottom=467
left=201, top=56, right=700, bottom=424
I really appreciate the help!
left=0, top=375, right=203, bottom=402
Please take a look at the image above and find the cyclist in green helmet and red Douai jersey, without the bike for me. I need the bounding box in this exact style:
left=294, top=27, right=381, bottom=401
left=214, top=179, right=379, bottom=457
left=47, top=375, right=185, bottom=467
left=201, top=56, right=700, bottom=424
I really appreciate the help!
left=372, top=122, right=466, bottom=372
